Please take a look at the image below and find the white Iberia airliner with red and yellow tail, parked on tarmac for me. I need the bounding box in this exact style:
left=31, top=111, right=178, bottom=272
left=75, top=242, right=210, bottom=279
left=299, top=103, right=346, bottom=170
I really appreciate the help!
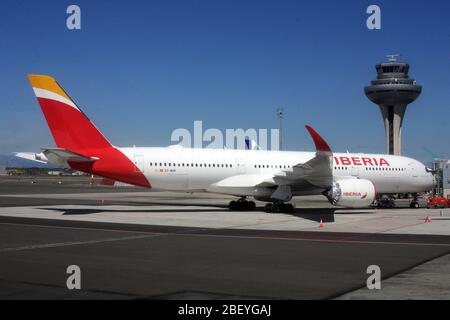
left=18, top=74, right=435, bottom=213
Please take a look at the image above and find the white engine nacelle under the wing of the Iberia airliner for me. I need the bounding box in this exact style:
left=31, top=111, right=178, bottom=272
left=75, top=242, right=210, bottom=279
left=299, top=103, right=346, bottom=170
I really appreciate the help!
left=326, top=179, right=376, bottom=208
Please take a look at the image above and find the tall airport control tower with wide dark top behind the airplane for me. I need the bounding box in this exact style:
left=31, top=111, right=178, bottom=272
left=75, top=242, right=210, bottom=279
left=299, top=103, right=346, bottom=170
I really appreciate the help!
left=364, top=55, right=422, bottom=155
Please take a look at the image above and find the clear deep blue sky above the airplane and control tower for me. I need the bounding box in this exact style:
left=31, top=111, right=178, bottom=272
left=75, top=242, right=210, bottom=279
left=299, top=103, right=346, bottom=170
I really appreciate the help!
left=0, top=0, right=450, bottom=161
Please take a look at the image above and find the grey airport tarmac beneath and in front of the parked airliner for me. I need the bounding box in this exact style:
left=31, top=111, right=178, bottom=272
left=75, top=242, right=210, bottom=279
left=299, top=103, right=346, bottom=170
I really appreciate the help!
left=0, top=177, right=450, bottom=299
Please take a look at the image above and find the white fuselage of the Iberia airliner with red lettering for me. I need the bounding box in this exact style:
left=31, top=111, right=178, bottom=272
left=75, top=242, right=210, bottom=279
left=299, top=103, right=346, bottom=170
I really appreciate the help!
left=120, top=146, right=434, bottom=195
